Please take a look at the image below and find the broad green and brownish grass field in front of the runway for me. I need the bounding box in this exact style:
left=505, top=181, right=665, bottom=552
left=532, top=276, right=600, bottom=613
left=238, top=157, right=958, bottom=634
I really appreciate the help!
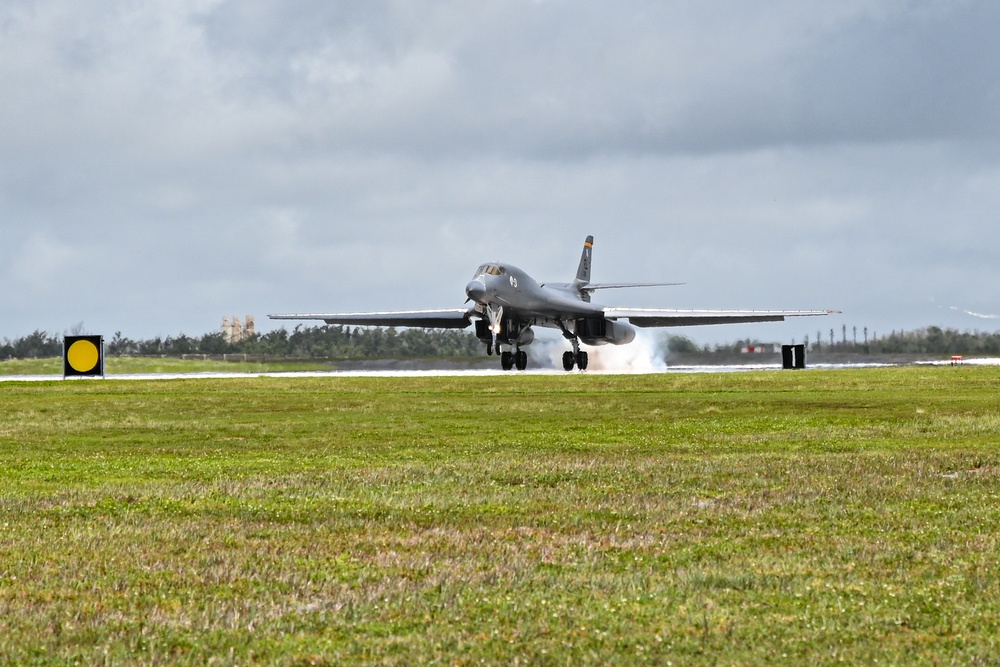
left=0, top=367, right=1000, bottom=665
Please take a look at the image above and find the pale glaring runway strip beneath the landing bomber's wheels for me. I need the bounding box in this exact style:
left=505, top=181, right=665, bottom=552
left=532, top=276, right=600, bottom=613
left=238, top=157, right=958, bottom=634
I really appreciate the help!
left=0, top=358, right=1000, bottom=382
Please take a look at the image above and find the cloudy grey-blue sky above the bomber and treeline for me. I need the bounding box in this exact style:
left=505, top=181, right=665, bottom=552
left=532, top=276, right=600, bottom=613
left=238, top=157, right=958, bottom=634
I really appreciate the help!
left=0, top=0, right=1000, bottom=350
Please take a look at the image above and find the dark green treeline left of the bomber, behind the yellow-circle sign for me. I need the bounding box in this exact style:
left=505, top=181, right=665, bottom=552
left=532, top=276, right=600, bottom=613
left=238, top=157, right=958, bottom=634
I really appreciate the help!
left=0, top=325, right=482, bottom=359
